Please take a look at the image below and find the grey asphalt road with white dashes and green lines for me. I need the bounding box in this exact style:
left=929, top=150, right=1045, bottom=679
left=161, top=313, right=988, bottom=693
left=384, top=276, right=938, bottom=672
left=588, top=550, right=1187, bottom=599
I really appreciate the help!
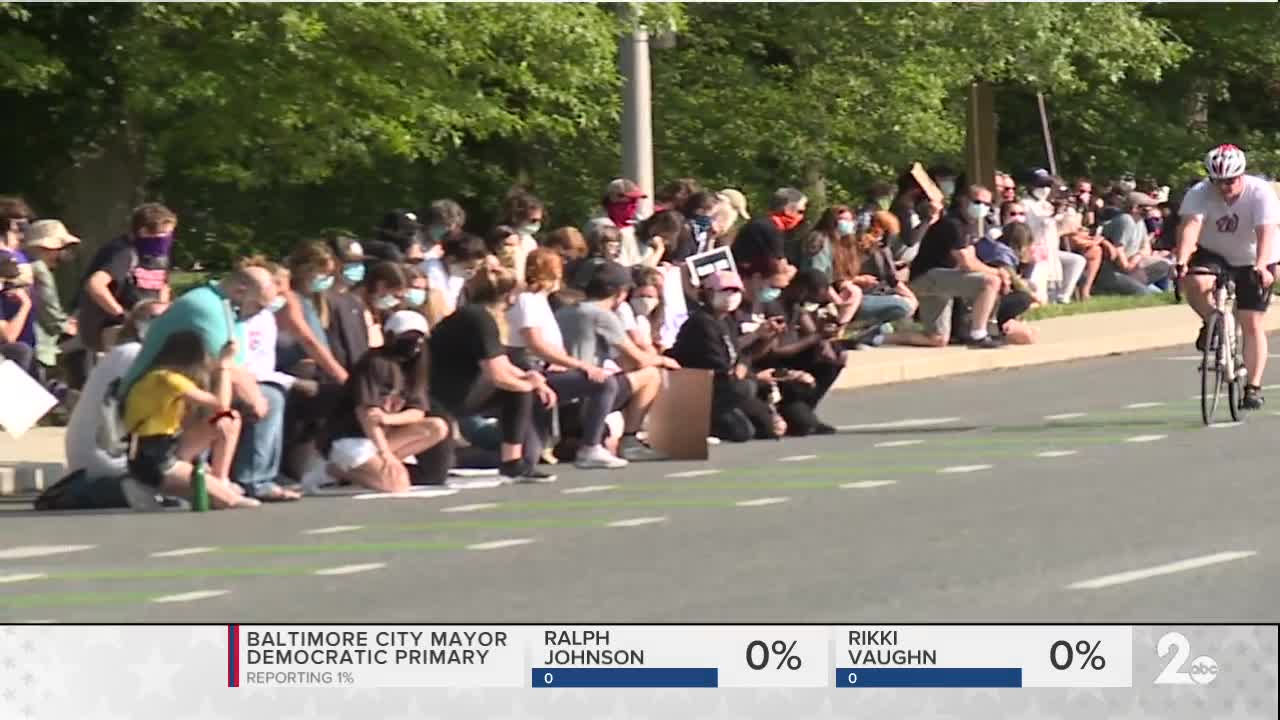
left=0, top=338, right=1280, bottom=623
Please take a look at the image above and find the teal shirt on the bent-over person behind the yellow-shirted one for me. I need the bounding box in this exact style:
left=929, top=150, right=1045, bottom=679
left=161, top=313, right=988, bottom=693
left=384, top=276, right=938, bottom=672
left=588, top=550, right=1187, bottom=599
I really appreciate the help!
left=120, top=283, right=247, bottom=397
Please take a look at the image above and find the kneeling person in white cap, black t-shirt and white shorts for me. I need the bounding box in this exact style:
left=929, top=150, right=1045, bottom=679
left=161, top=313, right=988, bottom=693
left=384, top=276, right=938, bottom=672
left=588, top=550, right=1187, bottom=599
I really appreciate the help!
left=313, top=310, right=452, bottom=492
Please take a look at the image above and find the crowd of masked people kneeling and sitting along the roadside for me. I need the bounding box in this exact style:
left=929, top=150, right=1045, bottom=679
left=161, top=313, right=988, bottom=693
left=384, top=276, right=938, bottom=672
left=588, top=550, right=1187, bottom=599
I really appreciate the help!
left=0, top=168, right=1176, bottom=507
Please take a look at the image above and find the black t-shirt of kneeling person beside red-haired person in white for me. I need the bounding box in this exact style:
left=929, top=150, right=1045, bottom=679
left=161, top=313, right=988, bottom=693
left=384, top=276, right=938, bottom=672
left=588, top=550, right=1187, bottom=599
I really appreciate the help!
left=431, top=305, right=506, bottom=410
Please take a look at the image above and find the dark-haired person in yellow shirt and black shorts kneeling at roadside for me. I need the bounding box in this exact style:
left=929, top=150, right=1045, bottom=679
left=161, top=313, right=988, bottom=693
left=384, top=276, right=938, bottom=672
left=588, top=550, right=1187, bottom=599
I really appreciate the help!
left=123, top=331, right=260, bottom=509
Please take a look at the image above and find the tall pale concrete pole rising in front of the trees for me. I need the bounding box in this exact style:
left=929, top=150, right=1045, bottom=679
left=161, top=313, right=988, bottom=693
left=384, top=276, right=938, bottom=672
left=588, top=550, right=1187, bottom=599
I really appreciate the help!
left=618, top=28, right=653, bottom=214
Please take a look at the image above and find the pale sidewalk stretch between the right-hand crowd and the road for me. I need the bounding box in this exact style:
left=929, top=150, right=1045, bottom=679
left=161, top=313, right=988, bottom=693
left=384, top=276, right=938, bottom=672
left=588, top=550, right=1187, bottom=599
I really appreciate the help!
left=835, top=305, right=1280, bottom=389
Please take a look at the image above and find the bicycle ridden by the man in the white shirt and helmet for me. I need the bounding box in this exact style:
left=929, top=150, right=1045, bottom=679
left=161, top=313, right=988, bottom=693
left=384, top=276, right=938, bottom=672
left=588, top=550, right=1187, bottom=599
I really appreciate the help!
left=1174, top=269, right=1248, bottom=425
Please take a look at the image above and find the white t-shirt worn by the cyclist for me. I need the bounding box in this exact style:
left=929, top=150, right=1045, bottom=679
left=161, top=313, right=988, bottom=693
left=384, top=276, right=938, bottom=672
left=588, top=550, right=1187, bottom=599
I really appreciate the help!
left=1179, top=176, right=1280, bottom=266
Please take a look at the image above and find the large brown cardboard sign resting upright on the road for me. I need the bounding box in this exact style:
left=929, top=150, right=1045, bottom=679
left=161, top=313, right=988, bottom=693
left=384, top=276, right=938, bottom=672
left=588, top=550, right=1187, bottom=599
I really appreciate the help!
left=648, top=369, right=712, bottom=460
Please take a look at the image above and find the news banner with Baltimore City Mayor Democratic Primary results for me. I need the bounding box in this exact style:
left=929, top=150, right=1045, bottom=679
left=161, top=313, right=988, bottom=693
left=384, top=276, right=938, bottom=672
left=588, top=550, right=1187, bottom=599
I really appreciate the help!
left=0, top=625, right=1277, bottom=720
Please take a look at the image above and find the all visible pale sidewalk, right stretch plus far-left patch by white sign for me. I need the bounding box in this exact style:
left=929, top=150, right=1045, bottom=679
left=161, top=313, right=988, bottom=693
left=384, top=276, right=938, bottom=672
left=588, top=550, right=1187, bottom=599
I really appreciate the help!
left=0, top=305, right=1280, bottom=496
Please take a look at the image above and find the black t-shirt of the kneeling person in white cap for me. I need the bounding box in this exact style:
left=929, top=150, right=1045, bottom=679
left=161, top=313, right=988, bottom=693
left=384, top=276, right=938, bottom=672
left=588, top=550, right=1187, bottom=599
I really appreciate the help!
left=328, top=348, right=431, bottom=442
